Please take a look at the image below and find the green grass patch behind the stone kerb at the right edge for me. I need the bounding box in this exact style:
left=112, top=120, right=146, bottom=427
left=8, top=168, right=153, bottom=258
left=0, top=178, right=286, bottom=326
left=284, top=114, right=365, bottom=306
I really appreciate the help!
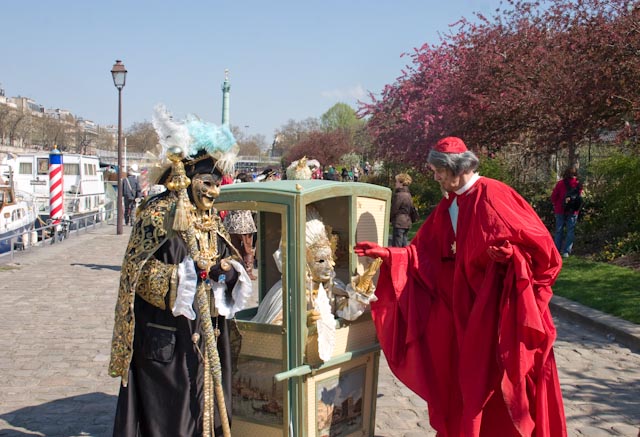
left=553, top=257, right=640, bottom=323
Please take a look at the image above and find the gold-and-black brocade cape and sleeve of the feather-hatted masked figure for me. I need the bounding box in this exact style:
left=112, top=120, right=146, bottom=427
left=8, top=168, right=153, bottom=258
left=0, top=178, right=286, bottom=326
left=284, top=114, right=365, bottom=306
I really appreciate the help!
left=109, top=193, right=232, bottom=386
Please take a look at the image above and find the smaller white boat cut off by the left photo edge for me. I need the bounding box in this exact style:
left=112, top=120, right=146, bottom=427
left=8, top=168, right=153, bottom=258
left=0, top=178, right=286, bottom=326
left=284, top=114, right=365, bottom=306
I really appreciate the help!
left=0, top=165, right=37, bottom=253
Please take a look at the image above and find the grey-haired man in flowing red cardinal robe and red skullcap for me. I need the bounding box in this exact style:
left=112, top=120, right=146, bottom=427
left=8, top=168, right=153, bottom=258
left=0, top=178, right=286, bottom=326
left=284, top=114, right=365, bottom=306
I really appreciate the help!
left=355, top=137, right=567, bottom=437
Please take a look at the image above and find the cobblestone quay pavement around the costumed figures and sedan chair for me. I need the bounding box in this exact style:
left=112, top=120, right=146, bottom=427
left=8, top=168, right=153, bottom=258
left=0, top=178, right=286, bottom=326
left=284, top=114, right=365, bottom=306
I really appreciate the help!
left=0, top=225, right=640, bottom=437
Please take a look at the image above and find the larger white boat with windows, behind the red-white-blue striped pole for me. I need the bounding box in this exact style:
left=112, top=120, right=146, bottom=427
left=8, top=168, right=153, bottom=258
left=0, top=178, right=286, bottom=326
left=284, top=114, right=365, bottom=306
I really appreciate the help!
left=3, top=152, right=106, bottom=225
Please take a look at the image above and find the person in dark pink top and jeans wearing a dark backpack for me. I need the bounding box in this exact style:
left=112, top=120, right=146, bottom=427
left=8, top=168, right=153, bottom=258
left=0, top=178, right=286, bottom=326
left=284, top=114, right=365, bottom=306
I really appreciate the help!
left=551, top=167, right=583, bottom=258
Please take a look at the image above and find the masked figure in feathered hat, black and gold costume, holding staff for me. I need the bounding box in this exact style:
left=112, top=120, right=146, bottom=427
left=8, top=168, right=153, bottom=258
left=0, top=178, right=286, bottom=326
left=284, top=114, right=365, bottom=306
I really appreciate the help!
left=109, top=106, right=252, bottom=437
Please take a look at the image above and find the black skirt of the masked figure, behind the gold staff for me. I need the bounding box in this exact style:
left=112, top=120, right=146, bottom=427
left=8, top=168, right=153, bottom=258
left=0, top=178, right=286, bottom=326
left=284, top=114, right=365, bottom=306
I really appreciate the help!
left=113, top=296, right=231, bottom=437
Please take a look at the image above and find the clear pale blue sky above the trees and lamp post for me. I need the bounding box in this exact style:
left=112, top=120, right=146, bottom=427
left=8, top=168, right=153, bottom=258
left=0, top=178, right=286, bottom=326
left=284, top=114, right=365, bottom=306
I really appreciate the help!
left=0, top=0, right=500, bottom=143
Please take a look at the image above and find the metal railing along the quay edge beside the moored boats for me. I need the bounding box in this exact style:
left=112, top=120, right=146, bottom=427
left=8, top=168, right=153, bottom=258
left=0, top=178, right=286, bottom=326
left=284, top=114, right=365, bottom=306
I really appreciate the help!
left=0, top=209, right=117, bottom=260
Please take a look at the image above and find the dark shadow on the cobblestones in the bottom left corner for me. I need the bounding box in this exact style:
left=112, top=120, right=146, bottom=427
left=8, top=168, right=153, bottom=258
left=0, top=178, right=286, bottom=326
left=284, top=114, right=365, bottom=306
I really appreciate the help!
left=0, top=393, right=118, bottom=437
